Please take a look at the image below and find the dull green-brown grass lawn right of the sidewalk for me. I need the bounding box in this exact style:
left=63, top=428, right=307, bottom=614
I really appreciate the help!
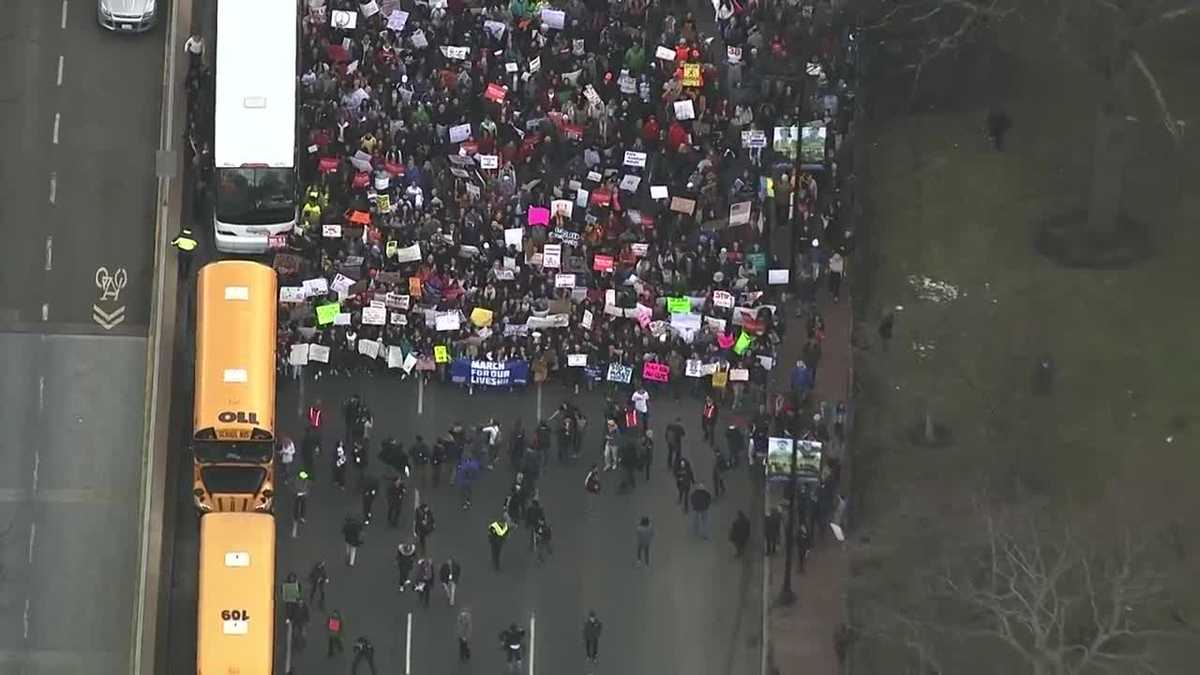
left=856, top=15, right=1200, bottom=673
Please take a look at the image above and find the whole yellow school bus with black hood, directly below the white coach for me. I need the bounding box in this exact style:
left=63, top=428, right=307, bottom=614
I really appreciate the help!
left=192, top=261, right=278, bottom=513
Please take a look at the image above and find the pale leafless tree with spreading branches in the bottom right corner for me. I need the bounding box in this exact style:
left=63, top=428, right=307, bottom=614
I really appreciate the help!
left=859, top=506, right=1198, bottom=675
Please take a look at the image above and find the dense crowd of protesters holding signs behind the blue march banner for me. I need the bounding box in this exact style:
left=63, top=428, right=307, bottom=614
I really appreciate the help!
left=260, top=0, right=864, bottom=398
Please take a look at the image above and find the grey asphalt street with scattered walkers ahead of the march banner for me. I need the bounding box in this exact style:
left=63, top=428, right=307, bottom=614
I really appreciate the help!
left=277, top=377, right=762, bottom=675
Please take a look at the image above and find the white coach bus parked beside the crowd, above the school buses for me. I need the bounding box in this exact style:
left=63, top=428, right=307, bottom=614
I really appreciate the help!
left=212, top=0, right=299, bottom=253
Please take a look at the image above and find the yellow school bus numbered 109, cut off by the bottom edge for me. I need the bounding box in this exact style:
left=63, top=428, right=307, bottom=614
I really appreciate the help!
left=196, top=513, right=275, bottom=675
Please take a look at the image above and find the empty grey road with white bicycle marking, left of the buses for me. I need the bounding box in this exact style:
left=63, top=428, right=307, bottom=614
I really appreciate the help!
left=0, top=0, right=164, bottom=675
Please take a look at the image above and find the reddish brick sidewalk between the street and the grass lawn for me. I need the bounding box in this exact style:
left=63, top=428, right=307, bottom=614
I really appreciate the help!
left=767, top=289, right=853, bottom=675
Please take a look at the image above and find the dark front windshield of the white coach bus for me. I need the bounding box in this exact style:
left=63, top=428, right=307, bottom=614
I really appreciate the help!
left=216, top=167, right=296, bottom=225
